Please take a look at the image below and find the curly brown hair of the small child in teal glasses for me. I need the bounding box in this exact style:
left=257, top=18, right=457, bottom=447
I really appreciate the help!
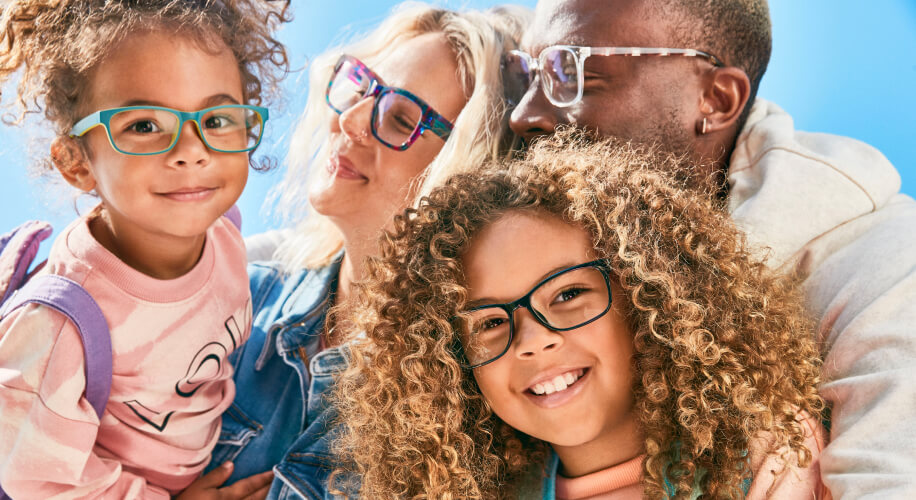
left=0, top=0, right=291, bottom=169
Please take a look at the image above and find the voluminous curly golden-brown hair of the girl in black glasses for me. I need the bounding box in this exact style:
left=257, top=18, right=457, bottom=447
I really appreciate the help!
left=335, top=134, right=823, bottom=498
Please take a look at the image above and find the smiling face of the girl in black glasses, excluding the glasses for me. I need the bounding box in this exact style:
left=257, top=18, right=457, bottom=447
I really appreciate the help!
left=462, top=211, right=642, bottom=475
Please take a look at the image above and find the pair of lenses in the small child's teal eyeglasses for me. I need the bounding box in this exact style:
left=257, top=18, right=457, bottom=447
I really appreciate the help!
left=108, top=106, right=264, bottom=154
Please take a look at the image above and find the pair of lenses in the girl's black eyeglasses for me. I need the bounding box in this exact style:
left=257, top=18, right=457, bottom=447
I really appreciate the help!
left=462, top=266, right=611, bottom=365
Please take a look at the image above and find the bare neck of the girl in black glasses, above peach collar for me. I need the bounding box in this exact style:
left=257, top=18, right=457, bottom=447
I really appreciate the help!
left=551, top=421, right=645, bottom=477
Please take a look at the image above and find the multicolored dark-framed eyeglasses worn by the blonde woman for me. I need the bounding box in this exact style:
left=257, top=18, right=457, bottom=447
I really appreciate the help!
left=326, top=55, right=453, bottom=151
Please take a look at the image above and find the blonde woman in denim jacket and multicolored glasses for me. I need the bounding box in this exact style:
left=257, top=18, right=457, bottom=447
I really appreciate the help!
left=203, top=3, right=528, bottom=498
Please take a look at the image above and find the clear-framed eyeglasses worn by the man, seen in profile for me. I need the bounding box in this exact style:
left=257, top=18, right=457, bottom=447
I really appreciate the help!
left=503, top=45, right=725, bottom=108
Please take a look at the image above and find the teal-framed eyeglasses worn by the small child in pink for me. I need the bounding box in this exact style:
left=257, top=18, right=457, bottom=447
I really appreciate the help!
left=70, top=104, right=268, bottom=156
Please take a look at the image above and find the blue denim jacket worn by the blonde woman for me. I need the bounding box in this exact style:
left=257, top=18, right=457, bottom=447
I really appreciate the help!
left=210, top=258, right=347, bottom=499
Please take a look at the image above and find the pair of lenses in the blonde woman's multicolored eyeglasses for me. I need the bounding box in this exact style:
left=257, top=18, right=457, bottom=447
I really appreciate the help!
left=327, top=59, right=423, bottom=148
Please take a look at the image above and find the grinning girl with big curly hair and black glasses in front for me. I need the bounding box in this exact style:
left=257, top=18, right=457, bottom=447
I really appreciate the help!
left=337, top=136, right=829, bottom=499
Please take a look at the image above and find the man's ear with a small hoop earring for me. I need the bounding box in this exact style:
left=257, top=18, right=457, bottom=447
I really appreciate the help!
left=697, top=66, right=751, bottom=135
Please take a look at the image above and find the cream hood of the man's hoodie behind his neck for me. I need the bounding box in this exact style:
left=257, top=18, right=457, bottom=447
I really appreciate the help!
left=728, top=99, right=900, bottom=266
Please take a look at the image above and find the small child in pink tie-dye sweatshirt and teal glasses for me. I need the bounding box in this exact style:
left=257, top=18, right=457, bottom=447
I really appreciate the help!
left=0, top=0, right=289, bottom=499
